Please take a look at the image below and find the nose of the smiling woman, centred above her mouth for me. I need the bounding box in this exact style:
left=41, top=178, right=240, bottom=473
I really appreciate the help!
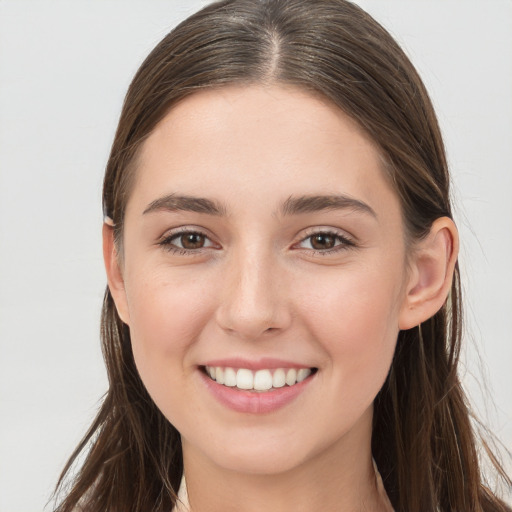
left=216, top=250, right=292, bottom=340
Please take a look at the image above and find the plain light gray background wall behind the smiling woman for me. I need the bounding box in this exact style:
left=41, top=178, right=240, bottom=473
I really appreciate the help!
left=0, top=0, right=512, bottom=512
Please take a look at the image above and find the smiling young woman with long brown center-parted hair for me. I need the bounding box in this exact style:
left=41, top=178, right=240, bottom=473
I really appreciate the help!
left=57, top=0, right=511, bottom=512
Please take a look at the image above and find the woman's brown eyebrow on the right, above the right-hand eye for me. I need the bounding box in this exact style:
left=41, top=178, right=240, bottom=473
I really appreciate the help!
left=281, top=195, right=377, bottom=218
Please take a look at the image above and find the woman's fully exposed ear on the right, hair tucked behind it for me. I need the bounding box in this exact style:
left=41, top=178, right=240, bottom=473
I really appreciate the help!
left=399, top=217, right=459, bottom=330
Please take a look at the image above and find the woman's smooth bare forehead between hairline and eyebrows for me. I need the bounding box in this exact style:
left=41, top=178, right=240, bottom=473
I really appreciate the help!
left=133, top=85, right=396, bottom=218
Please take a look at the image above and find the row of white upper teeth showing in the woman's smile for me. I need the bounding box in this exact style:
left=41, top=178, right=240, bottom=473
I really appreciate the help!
left=206, top=366, right=311, bottom=391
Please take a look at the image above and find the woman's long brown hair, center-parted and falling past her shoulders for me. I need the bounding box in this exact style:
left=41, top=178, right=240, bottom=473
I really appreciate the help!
left=56, top=0, right=512, bottom=512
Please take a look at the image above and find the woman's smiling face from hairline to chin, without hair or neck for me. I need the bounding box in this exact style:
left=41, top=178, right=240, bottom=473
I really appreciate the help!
left=111, top=86, right=408, bottom=473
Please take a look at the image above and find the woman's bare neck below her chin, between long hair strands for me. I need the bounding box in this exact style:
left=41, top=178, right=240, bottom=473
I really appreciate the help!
left=178, top=408, right=389, bottom=512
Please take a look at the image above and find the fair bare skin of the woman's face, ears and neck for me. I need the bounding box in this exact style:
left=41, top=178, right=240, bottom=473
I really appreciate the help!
left=104, top=85, right=458, bottom=512
